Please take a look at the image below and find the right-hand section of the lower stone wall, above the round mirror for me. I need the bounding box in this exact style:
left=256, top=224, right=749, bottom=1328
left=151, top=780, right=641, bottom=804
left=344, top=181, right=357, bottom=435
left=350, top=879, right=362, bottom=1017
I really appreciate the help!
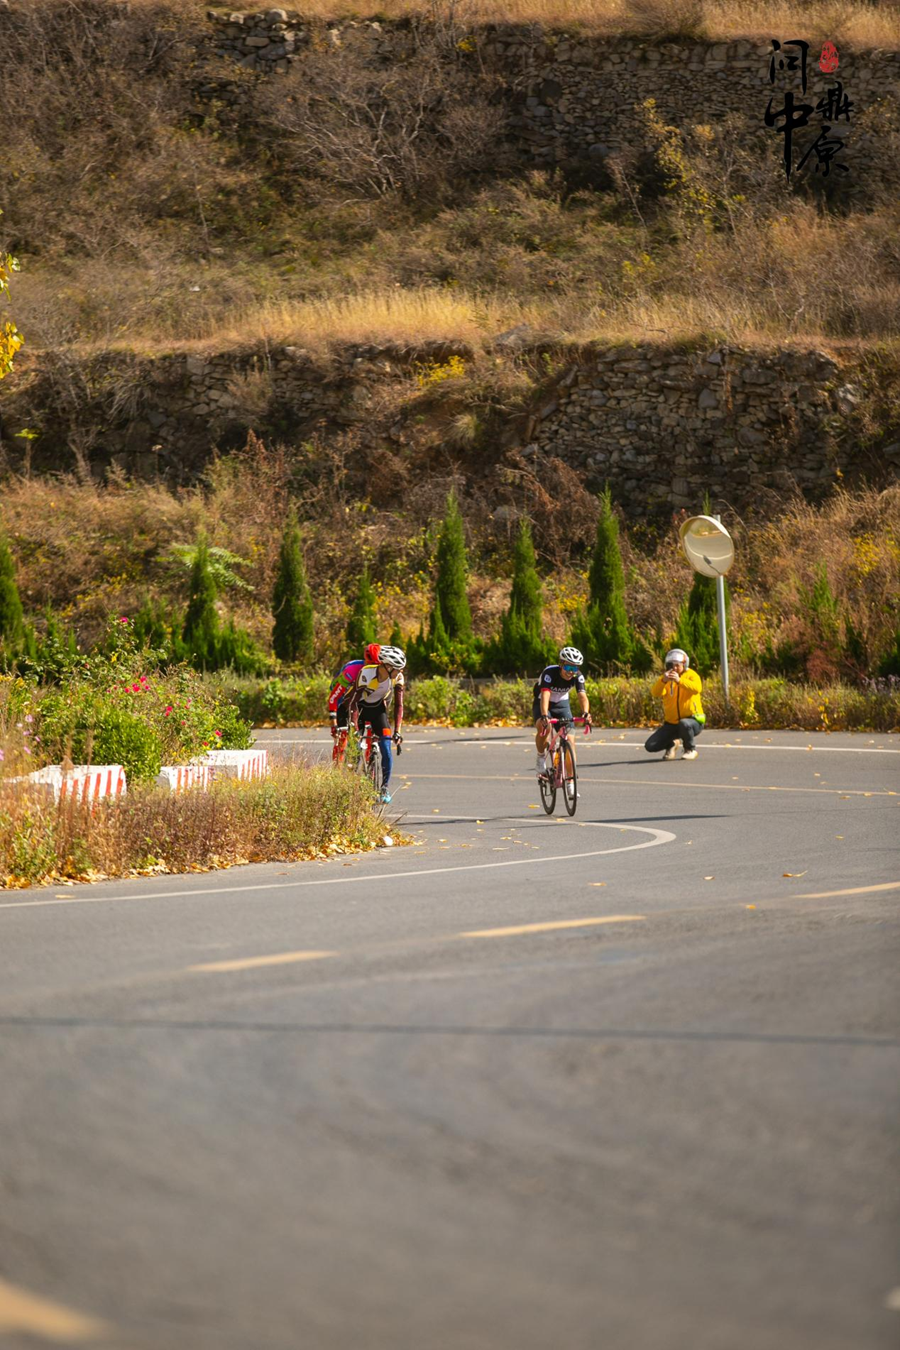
left=524, top=346, right=900, bottom=513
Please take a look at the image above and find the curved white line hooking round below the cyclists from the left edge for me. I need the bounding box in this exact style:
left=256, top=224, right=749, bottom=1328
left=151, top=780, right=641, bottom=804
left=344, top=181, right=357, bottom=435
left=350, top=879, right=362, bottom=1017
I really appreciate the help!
left=0, top=815, right=676, bottom=910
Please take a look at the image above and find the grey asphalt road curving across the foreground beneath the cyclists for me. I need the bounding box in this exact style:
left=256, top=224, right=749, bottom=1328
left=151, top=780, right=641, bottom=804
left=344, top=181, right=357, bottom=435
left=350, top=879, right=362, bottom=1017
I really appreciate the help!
left=0, top=730, right=900, bottom=1350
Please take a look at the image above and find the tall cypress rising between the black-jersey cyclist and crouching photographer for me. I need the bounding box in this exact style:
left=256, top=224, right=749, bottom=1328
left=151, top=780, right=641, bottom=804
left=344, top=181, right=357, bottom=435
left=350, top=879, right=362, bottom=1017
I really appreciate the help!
left=572, top=486, right=646, bottom=670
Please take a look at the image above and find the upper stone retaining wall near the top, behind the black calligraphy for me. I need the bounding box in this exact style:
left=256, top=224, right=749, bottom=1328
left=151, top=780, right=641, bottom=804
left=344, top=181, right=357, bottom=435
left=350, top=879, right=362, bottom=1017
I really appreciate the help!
left=201, top=9, right=900, bottom=192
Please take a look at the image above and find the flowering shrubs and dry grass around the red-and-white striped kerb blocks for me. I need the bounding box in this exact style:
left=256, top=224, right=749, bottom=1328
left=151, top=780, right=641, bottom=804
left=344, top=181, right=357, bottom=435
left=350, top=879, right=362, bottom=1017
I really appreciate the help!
left=0, top=612, right=401, bottom=888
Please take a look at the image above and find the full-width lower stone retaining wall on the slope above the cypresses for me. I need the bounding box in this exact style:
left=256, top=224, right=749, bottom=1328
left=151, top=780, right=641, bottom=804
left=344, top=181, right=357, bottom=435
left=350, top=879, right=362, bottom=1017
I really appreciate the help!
left=4, top=342, right=900, bottom=514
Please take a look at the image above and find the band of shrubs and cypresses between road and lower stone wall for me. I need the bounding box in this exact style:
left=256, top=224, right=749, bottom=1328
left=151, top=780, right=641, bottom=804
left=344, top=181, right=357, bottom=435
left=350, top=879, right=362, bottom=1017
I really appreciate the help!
left=0, top=464, right=900, bottom=734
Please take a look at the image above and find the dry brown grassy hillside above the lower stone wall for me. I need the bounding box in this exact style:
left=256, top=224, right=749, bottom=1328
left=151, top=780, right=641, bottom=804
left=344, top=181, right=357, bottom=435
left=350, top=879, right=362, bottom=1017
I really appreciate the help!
left=0, top=0, right=900, bottom=352
